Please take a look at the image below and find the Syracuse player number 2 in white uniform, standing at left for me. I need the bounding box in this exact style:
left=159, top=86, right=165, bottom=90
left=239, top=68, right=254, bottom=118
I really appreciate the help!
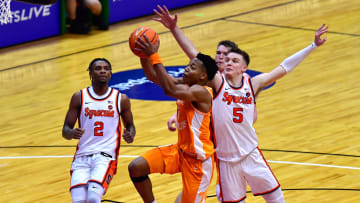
left=62, top=58, right=135, bottom=203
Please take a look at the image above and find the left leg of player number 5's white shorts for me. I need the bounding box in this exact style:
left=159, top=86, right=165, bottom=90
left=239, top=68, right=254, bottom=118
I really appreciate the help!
left=218, top=160, right=246, bottom=202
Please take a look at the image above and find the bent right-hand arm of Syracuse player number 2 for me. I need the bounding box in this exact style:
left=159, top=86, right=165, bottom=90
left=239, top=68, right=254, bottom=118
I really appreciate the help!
left=120, top=94, right=136, bottom=143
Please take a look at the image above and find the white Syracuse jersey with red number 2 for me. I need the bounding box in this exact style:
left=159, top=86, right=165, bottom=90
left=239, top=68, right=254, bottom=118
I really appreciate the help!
left=76, top=87, right=121, bottom=159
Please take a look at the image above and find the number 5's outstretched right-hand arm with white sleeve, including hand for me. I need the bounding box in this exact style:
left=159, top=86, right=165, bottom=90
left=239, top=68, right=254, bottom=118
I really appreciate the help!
left=251, top=24, right=328, bottom=96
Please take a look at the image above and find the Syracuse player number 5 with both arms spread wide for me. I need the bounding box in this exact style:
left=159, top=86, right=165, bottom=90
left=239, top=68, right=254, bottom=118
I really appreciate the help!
left=155, top=6, right=328, bottom=203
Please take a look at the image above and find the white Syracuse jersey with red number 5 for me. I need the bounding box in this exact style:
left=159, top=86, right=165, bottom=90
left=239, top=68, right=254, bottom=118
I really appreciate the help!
left=212, top=75, right=258, bottom=162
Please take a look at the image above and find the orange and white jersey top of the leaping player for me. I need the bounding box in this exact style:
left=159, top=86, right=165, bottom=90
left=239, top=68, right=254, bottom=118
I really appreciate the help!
left=176, top=86, right=214, bottom=160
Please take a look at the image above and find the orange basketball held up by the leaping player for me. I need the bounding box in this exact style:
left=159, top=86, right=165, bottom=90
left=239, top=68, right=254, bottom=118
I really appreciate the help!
left=129, top=27, right=159, bottom=58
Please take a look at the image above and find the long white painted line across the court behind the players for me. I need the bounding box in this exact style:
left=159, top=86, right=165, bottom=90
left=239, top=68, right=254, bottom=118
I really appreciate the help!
left=0, top=155, right=360, bottom=170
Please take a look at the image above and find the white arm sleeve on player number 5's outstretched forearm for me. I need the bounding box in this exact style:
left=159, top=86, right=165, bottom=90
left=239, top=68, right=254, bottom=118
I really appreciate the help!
left=280, top=42, right=317, bottom=73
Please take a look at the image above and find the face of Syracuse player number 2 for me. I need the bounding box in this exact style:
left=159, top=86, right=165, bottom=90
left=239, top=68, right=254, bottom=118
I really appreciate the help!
left=90, top=60, right=112, bottom=84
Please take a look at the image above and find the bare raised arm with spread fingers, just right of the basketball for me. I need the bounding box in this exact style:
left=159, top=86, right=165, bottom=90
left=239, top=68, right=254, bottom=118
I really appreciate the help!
left=153, top=5, right=199, bottom=59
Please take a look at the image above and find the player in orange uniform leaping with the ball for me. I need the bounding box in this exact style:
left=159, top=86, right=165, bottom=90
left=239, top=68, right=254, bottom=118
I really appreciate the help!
left=129, top=36, right=218, bottom=203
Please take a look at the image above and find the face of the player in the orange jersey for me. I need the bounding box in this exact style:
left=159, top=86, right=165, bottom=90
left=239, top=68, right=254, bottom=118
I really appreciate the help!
left=183, top=58, right=206, bottom=86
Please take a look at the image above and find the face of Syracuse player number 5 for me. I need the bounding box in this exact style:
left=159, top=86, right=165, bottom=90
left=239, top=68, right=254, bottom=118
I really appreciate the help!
left=224, top=52, right=247, bottom=77
